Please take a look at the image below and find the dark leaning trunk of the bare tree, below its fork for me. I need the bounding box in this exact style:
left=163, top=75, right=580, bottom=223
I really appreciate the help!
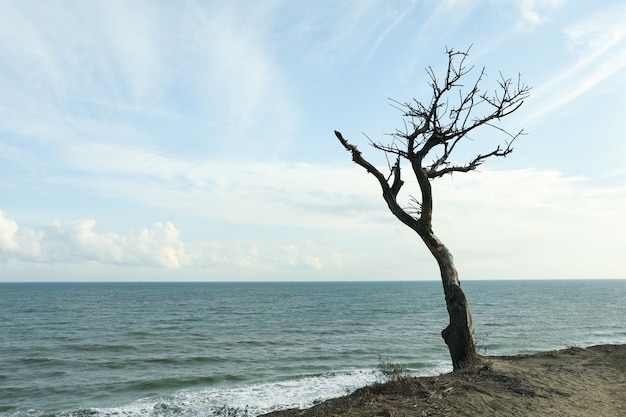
left=420, top=230, right=476, bottom=370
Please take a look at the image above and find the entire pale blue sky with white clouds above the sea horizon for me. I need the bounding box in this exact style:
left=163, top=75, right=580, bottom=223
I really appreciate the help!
left=0, top=0, right=626, bottom=282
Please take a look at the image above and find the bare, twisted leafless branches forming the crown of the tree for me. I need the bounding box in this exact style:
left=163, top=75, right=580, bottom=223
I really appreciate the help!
left=335, top=49, right=530, bottom=227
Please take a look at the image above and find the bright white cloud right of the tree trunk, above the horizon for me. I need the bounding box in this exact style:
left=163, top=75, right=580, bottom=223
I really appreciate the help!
left=435, top=170, right=626, bottom=278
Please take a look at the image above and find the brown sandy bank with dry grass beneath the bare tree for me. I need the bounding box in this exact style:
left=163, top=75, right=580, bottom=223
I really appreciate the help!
left=265, top=345, right=626, bottom=417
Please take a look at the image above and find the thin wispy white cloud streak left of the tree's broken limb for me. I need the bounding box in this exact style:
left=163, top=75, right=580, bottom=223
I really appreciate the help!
left=56, top=143, right=382, bottom=228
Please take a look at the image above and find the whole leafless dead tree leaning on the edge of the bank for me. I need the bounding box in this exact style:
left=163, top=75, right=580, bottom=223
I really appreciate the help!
left=335, top=50, right=530, bottom=369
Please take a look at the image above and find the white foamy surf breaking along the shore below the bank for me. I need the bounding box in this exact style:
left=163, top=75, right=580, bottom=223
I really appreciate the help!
left=0, top=361, right=450, bottom=417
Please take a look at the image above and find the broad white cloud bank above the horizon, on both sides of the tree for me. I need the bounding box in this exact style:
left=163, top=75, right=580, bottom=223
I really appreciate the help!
left=0, top=164, right=626, bottom=279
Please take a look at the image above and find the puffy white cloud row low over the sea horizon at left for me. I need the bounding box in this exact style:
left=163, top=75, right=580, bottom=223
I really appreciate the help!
left=0, top=211, right=352, bottom=271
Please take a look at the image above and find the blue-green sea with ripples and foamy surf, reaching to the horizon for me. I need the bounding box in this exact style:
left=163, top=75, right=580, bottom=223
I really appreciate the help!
left=0, top=280, right=626, bottom=417
